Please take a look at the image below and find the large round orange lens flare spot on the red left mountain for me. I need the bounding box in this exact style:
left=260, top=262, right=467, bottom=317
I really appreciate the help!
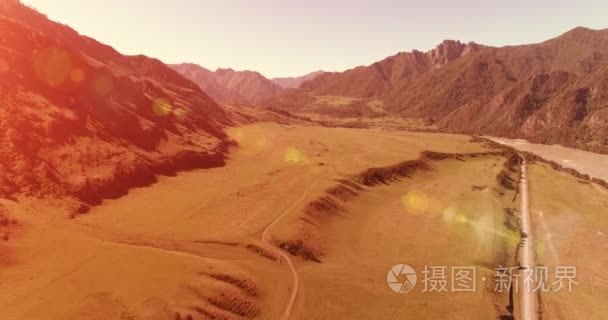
left=34, top=48, right=72, bottom=87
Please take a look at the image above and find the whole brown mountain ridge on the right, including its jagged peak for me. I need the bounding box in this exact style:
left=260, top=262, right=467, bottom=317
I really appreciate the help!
left=269, top=27, right=608, bottom=152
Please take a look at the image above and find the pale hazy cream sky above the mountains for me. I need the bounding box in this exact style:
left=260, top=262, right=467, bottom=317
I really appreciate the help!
left=22, top=0, right=608, bottom=77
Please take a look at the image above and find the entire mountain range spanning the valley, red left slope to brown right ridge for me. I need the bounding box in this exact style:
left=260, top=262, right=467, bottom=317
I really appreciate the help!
left=0, top=0, right=608, bottom=210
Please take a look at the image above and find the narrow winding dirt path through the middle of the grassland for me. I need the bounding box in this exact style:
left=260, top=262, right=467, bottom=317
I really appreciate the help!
left=261, top=175, right=321, bottom=320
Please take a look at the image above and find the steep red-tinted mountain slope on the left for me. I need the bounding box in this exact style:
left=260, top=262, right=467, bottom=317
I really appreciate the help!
left=0, top=0, right=230, bottom=211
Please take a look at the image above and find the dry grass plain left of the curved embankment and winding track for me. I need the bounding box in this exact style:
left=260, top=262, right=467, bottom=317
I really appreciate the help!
left=0, top=124, right=494, bottom=319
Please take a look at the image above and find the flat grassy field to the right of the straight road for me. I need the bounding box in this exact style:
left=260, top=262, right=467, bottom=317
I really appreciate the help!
left=529, top=164, right=608, bottom=319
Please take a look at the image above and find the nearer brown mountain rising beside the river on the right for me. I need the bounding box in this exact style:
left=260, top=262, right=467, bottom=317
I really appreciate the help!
left=386, top=28, right=608, bottom=150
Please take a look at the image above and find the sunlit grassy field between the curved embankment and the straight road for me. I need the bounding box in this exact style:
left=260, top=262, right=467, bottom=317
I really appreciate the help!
left=276, top=157, right=519, bottom=319
